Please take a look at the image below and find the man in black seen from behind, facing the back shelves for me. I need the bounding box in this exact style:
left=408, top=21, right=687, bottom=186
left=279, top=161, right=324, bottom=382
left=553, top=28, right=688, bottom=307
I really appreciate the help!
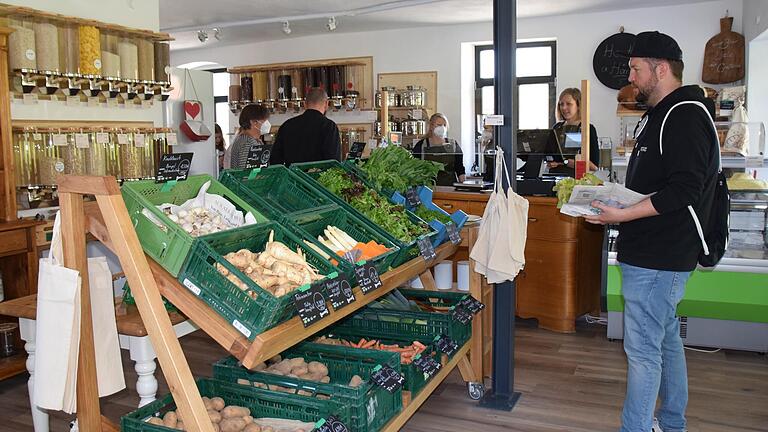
left=269, top=88, right=341, bottom=165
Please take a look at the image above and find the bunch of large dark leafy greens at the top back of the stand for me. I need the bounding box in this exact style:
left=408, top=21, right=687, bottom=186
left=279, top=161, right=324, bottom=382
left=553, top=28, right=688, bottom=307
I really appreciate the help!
left=358, top=145, right=444, bottom=193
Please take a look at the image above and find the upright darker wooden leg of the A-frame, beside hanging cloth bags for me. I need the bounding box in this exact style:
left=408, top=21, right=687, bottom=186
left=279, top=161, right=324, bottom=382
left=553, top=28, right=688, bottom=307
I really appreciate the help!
left=59, top=192, right=101, bottom=431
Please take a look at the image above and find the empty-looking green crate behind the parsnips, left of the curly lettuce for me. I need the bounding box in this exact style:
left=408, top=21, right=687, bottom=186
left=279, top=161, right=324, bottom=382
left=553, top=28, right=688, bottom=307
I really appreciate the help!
left=219, top=165, right=334, bottom=220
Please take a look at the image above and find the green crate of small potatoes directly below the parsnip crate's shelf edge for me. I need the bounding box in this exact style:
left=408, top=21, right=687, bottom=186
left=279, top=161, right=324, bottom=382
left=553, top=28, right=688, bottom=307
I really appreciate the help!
left=213, top=342, right=403, bottom=432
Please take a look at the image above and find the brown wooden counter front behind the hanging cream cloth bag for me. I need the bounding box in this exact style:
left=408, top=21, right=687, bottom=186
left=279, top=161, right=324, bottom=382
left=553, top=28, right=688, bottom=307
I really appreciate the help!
left=433, top=186, right=603, bottom=332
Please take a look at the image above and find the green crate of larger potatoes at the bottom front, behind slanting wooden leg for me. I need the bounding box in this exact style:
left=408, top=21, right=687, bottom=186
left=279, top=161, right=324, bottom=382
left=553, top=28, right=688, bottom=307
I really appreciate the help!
left=120, top=379, right=336, bottom=432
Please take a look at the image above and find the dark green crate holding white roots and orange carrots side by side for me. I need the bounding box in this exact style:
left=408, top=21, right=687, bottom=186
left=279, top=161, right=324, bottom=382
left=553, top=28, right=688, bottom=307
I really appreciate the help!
left=285, top=205, right=400, bottom=278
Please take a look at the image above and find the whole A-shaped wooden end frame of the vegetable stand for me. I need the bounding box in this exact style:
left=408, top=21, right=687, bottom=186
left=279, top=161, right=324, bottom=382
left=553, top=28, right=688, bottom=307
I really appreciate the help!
left=58, top=176, right=213, bottom=432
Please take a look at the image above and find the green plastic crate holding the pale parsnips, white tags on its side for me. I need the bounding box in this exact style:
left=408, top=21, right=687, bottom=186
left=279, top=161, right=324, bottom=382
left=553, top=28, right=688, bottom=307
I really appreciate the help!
left=179, top=222, right=339, bottom=340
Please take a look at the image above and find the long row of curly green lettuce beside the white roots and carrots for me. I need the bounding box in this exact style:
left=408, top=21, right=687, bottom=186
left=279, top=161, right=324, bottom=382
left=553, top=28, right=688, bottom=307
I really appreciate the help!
left=317, top=168, right=429, bottom=243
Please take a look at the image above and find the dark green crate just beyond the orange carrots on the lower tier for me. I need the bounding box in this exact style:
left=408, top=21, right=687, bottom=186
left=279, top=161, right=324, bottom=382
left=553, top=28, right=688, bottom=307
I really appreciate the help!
left=334, top=289, right=472, bottom=346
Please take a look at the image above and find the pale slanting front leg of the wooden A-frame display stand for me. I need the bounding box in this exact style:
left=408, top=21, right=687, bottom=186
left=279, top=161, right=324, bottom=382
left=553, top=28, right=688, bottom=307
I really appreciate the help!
left=94, top=194, right=213, bottom=432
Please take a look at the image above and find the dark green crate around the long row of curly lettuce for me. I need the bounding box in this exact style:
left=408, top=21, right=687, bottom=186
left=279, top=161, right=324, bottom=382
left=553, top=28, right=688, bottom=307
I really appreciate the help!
left=291, top=160, right=437, bottom=267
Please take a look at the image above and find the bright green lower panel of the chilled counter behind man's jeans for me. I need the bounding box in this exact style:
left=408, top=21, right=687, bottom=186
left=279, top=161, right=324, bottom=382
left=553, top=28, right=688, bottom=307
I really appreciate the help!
left=607, top=265, right=768, bottom=323
